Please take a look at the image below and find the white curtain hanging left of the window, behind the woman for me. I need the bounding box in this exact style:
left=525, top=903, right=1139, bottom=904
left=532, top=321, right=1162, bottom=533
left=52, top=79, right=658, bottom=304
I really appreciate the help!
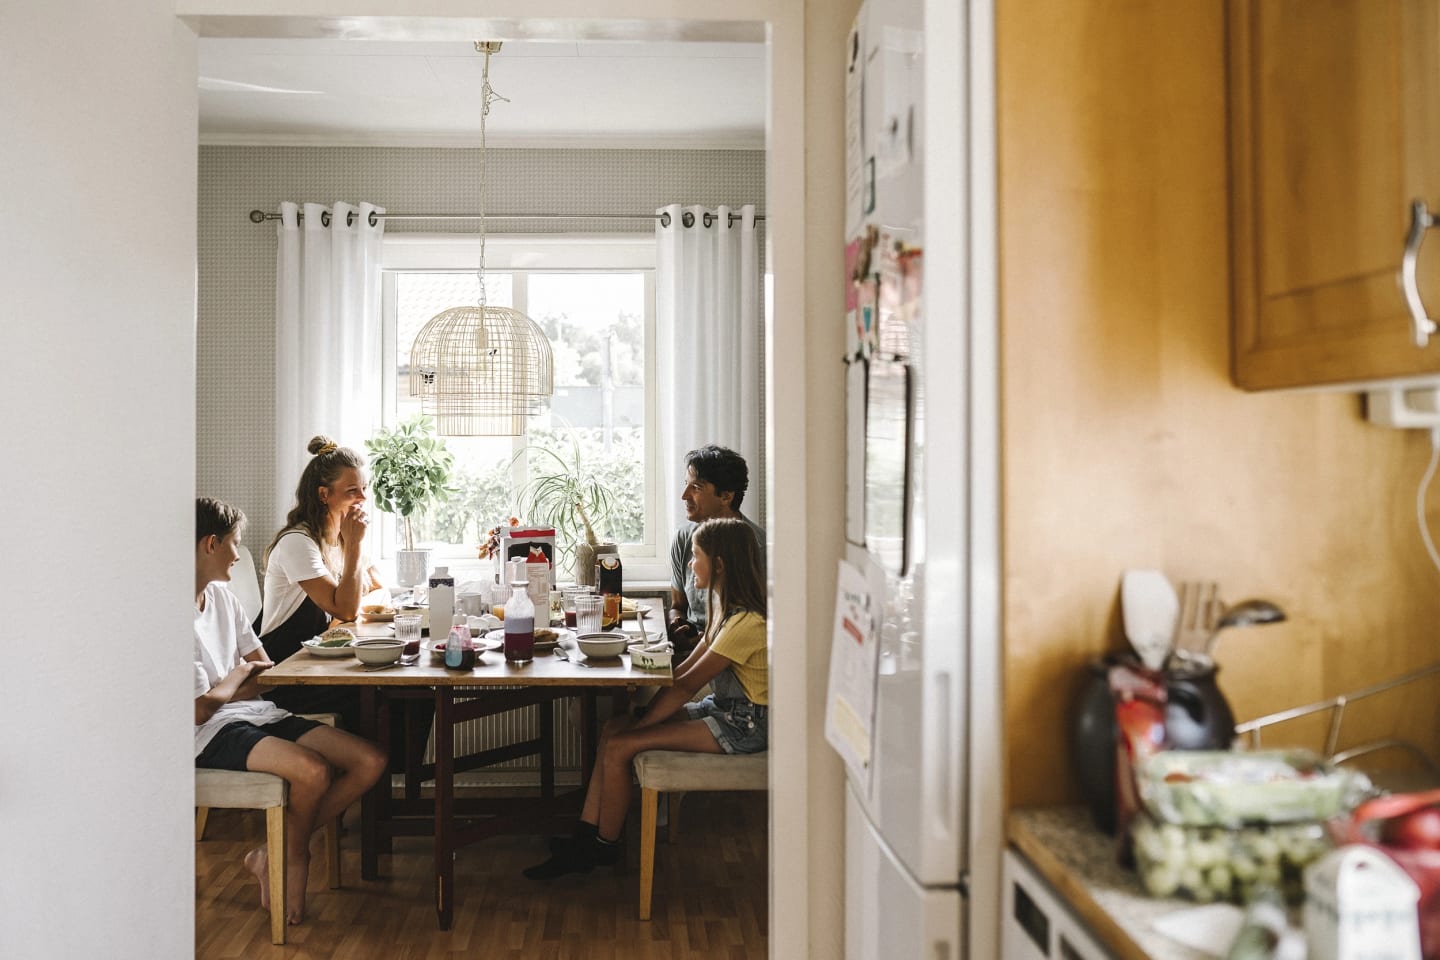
left=275, top=203, right=384, bottom=521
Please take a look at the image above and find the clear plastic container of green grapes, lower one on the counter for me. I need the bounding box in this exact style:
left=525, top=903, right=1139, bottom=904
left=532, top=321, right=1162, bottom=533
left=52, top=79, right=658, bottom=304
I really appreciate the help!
left=1130, top=816, right=1332, bottom=904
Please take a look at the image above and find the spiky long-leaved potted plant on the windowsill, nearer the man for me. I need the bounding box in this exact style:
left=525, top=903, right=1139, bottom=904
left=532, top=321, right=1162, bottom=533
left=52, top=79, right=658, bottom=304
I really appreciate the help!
left=518, top=432, right=615, bottom=584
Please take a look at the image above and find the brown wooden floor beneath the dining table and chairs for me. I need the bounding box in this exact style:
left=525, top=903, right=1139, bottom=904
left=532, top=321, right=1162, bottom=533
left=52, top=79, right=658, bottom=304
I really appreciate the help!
left=194, top=793, right=768, bottom=960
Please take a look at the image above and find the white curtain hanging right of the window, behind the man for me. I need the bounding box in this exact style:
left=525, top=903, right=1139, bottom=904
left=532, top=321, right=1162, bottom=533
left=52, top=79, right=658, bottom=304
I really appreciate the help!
left=655, top=204, right=763, bottom=543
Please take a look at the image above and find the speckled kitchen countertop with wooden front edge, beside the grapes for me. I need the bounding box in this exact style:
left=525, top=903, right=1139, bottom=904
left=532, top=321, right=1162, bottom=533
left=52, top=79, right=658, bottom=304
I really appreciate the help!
left=1005, top=806, right=1207, bottom=960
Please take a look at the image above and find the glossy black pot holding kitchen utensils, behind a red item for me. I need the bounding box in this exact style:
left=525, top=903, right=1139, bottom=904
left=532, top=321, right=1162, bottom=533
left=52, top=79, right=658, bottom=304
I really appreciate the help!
left=1071, top=652, right=1236, bottom=833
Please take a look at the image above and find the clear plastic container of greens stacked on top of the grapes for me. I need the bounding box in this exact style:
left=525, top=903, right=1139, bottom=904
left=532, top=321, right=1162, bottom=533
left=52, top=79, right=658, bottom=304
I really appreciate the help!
left=1136, top=750, right=1372, bottom=828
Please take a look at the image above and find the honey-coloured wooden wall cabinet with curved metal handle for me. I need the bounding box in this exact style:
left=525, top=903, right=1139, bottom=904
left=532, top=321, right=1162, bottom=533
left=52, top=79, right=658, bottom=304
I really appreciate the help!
left=1227, top=0, right=1440, bottom=390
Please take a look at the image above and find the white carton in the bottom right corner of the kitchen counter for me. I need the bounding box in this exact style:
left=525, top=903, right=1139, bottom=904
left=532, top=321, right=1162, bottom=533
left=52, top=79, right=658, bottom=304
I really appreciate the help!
left=1305, top=843, right=1420, bottom=960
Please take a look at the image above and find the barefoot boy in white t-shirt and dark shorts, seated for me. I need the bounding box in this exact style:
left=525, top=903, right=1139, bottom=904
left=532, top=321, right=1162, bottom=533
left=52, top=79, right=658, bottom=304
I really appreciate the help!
left=194, top=497, right=386, bottom=924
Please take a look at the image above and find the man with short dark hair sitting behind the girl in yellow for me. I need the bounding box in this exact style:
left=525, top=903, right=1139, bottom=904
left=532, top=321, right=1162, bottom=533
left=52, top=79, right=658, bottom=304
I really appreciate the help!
left=665, top=443, right=766, bottom=653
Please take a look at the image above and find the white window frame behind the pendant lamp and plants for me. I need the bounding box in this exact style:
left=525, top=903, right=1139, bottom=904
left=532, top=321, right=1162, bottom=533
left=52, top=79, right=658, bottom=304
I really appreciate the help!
left=379, top=233, right=671, bottom=583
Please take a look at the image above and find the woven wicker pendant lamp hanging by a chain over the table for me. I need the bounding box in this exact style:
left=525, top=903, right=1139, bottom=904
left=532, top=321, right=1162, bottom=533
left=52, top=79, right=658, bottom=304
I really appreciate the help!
left=410, top=40, right=554, bottom=436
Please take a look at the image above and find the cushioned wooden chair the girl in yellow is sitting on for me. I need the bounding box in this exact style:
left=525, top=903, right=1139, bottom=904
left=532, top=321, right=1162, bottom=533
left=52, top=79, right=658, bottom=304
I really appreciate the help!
left=635, top=750, right=770, bottom=920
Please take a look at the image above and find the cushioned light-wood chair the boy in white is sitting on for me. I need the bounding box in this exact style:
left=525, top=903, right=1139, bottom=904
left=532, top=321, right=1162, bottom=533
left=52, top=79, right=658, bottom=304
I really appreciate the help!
left=194, top=714, right=340, bottom=944
